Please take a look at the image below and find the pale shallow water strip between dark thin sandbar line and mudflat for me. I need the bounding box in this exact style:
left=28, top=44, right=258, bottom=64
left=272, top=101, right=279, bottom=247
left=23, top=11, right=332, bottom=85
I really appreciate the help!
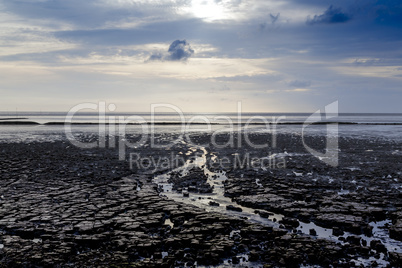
left=0, top=125, right=402, bottom=144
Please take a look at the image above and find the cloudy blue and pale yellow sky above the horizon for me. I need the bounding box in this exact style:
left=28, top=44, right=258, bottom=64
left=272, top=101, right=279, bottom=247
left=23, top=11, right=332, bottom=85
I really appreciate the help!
left=0, top=0, right=402, bottom=113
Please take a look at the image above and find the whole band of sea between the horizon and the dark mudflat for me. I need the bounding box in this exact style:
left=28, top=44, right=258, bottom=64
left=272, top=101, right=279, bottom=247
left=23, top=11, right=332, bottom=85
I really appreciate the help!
left=0, top=112, right=402, bottom=142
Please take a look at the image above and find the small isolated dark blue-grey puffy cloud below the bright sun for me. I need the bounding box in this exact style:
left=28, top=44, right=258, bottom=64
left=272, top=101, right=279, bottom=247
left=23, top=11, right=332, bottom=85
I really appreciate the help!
left=147, top=40, right=194, bottom=61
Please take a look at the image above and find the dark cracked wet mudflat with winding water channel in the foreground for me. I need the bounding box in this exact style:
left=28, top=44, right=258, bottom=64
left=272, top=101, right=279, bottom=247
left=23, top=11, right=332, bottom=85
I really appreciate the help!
left=0, top=134, right=402, bottom=267
